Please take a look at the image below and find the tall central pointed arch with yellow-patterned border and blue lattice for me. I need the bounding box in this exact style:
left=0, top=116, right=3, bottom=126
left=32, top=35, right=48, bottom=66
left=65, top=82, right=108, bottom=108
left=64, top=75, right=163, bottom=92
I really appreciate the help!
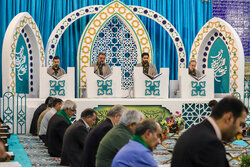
left=78, top=0, right=153, bottom=94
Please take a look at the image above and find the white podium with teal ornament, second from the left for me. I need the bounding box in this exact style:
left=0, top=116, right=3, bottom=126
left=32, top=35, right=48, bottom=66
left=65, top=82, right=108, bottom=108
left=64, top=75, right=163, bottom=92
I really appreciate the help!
left=86, top=67, right=122, bottom=98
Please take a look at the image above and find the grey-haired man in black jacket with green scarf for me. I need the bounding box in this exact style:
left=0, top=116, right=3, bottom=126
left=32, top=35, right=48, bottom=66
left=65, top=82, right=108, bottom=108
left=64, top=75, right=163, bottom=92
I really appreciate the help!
left=46, top=100, right=76, bottom=157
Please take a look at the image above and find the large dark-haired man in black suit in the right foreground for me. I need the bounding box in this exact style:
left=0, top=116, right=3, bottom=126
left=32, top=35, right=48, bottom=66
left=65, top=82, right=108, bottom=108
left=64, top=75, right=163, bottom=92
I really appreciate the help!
left=171, top=96, right=248, bottom=167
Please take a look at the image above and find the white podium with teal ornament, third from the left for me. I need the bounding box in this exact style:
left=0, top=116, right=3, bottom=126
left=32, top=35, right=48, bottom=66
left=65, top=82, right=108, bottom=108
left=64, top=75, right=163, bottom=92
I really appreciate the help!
left=134, top=67, right=169, bottom=99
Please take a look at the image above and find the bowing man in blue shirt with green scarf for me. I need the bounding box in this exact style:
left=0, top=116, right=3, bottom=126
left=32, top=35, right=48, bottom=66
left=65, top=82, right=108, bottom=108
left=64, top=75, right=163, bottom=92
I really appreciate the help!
left=111, top=119, right=162, bottom=167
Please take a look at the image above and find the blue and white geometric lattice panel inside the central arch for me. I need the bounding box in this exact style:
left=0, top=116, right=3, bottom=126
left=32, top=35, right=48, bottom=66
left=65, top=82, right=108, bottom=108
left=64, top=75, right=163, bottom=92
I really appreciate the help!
left=91, top=16, right=138, bottom=90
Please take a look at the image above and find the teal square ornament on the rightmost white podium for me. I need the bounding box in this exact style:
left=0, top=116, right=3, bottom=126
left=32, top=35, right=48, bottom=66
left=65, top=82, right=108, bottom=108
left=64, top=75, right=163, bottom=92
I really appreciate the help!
left=191, top=81, right=206, bottom=96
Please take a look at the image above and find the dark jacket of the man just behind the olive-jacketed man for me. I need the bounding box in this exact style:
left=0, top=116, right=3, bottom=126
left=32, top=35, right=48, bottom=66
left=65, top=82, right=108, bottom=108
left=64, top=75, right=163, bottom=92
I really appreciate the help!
left=82, top=118, right=113, bottom=167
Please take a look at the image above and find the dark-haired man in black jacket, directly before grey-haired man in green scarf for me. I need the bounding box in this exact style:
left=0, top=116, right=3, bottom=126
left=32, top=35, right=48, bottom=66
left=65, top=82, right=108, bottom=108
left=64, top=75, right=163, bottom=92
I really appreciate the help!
left=61, top=108, right=97, bottom=167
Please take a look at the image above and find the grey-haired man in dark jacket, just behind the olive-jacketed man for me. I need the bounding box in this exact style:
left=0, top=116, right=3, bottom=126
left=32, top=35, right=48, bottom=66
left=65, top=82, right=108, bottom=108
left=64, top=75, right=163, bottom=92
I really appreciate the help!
left=81, top=105, right=126, bottom=167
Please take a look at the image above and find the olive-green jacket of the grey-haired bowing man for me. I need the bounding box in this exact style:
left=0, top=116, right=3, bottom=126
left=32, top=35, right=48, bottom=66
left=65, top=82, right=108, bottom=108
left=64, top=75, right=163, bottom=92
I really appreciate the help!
left=96, top=124, right=133, bottom=167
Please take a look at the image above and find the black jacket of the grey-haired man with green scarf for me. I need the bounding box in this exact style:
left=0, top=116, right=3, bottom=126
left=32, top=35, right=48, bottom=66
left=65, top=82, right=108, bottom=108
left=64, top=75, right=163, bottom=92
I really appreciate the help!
left=46, top=114, right=69, bottom=157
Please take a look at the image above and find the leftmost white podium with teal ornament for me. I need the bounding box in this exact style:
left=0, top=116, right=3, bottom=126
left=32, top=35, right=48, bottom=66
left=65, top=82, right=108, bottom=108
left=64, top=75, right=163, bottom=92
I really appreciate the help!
left=39, top=67, right=75, bottom=99
